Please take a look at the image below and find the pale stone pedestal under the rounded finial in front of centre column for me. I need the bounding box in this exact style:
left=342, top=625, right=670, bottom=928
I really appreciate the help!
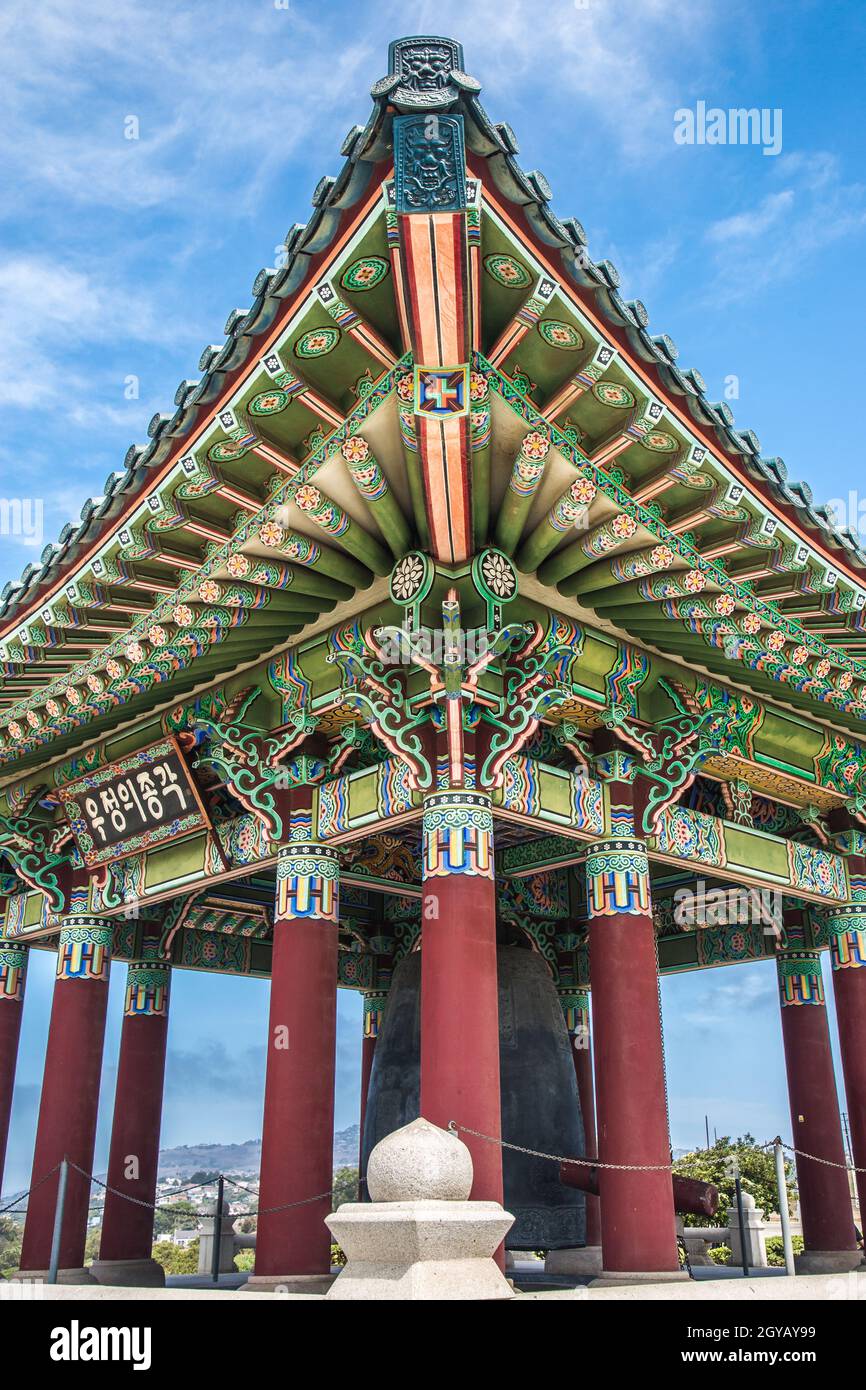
left=325, top=1200, right=514, bottom=1302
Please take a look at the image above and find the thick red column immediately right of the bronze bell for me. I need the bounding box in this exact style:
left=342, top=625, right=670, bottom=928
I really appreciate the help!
left=587, top=837, right=688, bottom=1279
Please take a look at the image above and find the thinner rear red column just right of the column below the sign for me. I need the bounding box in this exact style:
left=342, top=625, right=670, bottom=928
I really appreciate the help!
left=90, top=938, right=170, bottom=1289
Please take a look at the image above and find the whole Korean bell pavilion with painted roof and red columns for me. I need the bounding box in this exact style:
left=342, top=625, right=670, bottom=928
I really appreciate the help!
left=0, top=38, right=866, bottom=1287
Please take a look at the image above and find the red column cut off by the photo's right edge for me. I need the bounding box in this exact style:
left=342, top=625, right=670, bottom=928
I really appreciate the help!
left=826, top=902, right=866, bottom=1223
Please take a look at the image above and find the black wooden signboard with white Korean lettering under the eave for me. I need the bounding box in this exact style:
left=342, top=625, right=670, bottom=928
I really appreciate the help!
left=58, top=738, right=210, bottom=869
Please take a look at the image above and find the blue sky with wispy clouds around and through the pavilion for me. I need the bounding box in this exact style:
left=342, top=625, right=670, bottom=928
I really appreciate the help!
left=0, top=0, right=866, bottom=1184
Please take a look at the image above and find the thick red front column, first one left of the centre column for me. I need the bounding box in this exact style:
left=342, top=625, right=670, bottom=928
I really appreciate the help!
left=245, top=787, right=339, bottom=1290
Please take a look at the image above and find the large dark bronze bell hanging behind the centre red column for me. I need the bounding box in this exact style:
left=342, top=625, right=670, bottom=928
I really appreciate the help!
left=363, top=945, right=587, bottom=1250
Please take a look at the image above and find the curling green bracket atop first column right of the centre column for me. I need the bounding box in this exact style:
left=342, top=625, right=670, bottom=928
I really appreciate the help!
left=602, top=677, right=731, bottom=835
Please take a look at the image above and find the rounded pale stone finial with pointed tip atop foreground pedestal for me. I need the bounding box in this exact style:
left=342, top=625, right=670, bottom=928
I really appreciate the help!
left=367, top=1118, right=473, bottom=1202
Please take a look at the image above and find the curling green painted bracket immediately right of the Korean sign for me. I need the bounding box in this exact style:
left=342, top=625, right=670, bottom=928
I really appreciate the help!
left=192, top=685, right=319, bottom=841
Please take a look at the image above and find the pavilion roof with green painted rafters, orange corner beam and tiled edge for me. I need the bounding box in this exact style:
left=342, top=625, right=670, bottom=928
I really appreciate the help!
left=0, top=39, right=866, bottom=770
